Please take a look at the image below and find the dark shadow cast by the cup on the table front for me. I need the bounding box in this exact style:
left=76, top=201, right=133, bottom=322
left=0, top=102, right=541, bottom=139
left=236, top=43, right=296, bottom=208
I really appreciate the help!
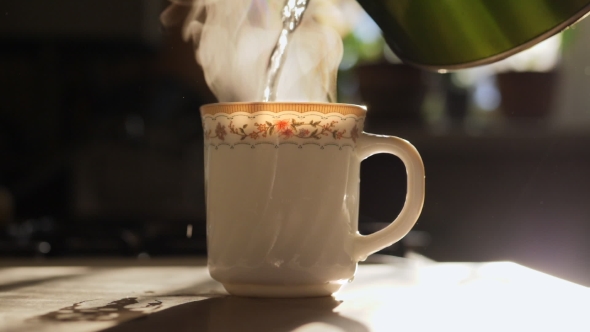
left=103, top=296, right=369, bottom=332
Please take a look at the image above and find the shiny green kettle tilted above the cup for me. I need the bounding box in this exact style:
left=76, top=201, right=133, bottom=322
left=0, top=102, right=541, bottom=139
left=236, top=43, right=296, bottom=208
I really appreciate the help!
left=357, top=0, right=590, bottom=71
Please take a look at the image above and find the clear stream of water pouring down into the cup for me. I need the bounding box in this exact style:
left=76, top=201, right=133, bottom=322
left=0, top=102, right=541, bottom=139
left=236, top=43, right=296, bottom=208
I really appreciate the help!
left=262, top=0, right=309, bottom=102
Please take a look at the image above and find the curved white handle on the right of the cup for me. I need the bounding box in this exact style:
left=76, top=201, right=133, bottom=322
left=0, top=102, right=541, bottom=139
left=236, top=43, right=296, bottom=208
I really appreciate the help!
left=354, top=133, right=424, bottom=261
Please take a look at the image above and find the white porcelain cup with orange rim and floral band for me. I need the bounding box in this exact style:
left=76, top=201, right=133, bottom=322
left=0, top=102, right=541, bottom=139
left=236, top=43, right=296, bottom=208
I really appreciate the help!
left=201, top=102, right=424, bottom=297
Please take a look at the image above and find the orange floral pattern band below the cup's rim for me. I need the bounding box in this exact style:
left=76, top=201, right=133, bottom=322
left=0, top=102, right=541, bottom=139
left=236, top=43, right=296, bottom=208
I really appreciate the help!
left=203, top=114, right=363, bottom=146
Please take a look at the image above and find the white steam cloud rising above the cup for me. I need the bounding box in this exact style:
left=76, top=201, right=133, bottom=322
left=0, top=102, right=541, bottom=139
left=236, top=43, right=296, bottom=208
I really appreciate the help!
left=162, top=0, right=343, bottom=102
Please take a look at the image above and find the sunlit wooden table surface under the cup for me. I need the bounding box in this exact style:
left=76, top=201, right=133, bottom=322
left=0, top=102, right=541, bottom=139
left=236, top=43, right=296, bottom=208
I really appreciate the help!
left=0, top=258, right=590, bottom=332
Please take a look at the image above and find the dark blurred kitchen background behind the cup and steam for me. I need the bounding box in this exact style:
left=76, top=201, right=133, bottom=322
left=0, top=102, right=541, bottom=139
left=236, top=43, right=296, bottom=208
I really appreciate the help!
left=0, top=0, right=590, bottom=286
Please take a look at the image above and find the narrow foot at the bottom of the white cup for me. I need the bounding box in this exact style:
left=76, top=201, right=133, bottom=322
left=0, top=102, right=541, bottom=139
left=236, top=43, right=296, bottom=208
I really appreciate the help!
left=223, top=283, right=342, bottom=298
